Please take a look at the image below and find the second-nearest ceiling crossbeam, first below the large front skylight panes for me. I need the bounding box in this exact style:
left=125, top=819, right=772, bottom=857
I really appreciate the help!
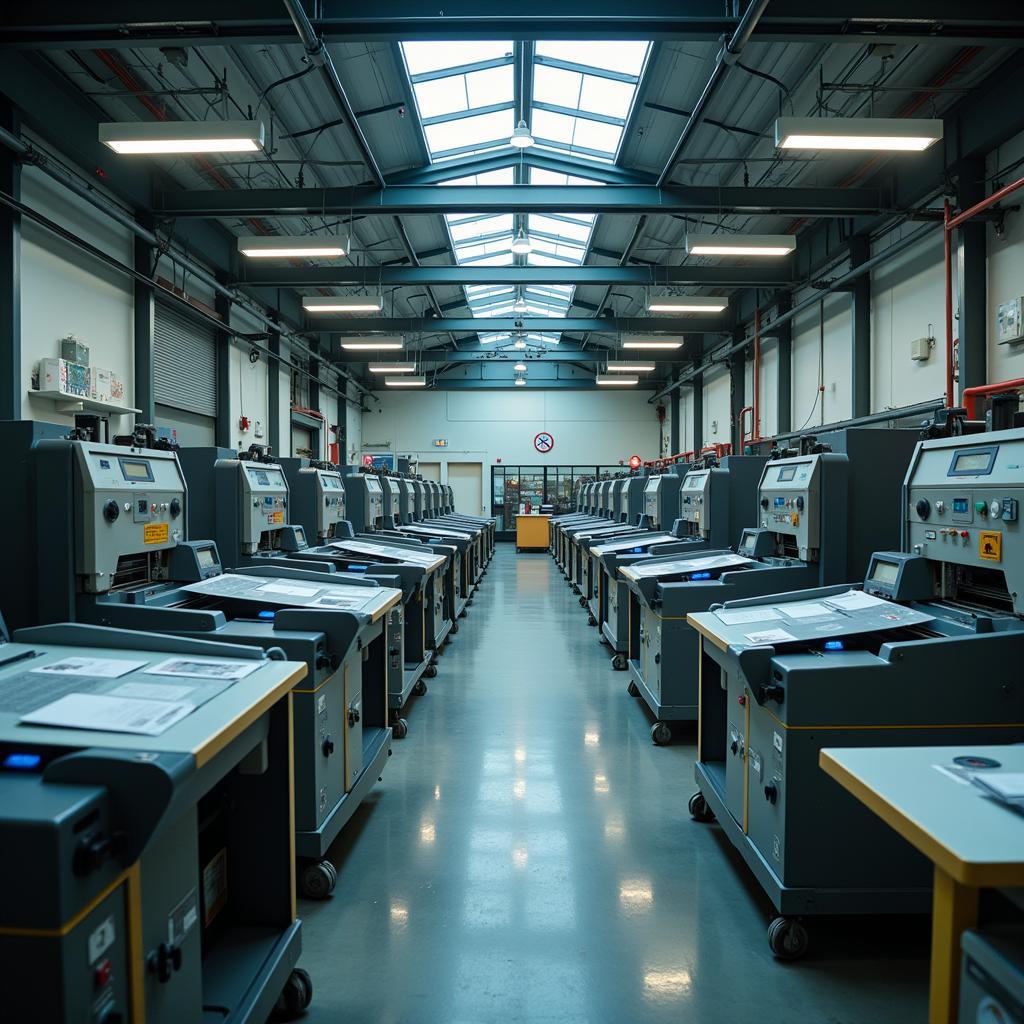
left=155, top=184, right=888, bottom=218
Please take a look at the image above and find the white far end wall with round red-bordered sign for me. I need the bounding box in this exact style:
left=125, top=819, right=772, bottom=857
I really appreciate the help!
left=361, top=390, right=658, bottom=471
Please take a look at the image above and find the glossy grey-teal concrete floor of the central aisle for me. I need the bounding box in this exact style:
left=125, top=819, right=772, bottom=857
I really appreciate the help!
left=299, top=545, right=928, bottom=1024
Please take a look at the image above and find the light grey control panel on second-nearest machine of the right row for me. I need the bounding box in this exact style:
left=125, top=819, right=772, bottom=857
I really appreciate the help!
left=758, top=455, right=821, bottom=561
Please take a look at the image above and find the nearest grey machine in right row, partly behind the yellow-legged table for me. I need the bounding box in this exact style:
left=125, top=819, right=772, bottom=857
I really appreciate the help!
left=690, top=429, right=1024, bottom=956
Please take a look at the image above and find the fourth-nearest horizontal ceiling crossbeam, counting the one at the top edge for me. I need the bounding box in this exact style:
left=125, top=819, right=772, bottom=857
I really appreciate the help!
left=304, top=315, right=730, bottom=334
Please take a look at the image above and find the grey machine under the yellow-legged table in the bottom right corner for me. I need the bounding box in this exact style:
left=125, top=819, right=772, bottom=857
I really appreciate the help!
left=957, top=925, right=1024, bottom=1024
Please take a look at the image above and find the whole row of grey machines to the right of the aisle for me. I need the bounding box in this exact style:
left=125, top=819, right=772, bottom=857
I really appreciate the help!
left=551, top=402, right=1024, bottom=974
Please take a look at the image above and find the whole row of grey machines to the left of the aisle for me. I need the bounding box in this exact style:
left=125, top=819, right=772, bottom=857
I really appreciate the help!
left=0, top=422, right=495, bottom=1024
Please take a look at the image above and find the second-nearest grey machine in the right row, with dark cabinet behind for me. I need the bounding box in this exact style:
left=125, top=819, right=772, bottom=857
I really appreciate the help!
left=618, top=428, right=915, bottom=743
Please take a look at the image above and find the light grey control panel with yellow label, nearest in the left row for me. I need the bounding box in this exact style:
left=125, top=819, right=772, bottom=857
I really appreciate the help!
left=71, top=441, right=187, bottom=593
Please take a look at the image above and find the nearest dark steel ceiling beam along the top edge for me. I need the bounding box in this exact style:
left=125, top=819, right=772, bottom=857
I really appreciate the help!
left=0, top=0, right=1024, bottom=49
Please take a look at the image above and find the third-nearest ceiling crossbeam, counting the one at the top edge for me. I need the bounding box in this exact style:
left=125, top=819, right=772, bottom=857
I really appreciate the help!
left=238, top=260, right=795, bottom=288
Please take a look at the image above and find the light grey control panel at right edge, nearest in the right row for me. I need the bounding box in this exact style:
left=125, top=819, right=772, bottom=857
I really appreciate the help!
left=904, top=428, right=1024, bottom=614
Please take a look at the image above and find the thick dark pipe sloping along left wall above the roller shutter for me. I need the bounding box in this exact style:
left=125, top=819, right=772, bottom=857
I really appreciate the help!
left=0, top=121, right=379, bottom=401
